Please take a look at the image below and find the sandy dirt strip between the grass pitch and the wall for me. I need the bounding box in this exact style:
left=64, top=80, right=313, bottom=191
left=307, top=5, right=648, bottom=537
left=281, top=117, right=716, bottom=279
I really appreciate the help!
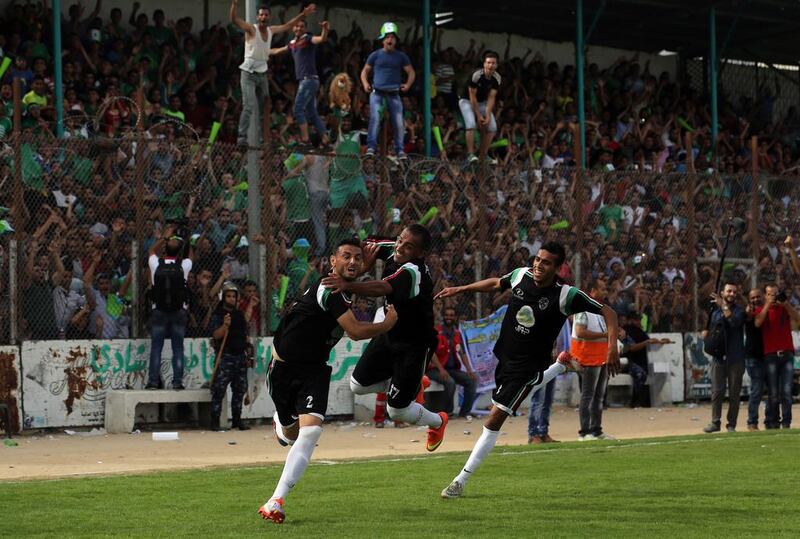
left=0, top=403, right=747, bottom=481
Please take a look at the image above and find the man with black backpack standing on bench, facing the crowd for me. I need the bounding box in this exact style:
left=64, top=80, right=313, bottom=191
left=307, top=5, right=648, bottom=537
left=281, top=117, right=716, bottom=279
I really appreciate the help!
left=145, top=222, right=192, bottom=389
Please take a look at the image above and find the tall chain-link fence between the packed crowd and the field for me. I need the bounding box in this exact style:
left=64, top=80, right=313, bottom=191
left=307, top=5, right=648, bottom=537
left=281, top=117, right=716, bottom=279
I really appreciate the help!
left=0, top=125, right=800, bottom=343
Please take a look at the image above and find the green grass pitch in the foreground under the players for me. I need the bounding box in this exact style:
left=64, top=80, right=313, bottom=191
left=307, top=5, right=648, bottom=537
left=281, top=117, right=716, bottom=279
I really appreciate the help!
left=0, top=430, right=800, bottom=539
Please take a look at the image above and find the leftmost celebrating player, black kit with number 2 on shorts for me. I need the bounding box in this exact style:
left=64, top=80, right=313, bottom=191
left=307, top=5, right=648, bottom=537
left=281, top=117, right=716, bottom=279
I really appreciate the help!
left=258, top=239, right=397, bottom=524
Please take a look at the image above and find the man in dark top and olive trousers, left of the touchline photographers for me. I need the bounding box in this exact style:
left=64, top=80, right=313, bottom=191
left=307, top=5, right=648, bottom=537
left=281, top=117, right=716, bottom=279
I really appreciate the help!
left=702, top=282, right=745, bottom=432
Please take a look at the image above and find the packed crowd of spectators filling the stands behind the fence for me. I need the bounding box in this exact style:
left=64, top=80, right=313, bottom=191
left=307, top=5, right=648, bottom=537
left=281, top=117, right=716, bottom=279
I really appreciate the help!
left=0, top=0, right=800, bottom=342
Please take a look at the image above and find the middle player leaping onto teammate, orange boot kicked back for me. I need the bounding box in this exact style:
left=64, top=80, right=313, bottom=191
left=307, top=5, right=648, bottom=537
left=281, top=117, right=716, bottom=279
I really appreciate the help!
left=322, top=224, right=447, bottom=451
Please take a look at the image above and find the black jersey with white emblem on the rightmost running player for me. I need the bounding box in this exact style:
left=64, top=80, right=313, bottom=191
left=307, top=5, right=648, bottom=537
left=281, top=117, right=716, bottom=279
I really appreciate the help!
left=494, top=268, right=603, bottom=373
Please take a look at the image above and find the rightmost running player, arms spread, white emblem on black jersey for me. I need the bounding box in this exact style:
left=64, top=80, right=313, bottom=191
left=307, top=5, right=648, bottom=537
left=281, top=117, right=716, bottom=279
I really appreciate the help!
left=437, top=242, right=619, bottom=498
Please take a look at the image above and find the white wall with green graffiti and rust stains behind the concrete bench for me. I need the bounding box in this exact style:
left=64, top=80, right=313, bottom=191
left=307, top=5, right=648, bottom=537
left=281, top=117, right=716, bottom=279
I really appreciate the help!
left=21, top=337, right=368, bottom=428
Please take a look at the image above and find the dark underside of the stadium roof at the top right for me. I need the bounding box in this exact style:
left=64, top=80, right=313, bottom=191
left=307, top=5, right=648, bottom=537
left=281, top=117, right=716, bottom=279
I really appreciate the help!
left=336, top=0, right=800, bottom=65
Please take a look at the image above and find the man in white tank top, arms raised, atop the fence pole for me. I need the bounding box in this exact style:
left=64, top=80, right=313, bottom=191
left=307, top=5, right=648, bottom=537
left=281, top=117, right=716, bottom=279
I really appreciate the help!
left=230, top=0, right=316, bottom=144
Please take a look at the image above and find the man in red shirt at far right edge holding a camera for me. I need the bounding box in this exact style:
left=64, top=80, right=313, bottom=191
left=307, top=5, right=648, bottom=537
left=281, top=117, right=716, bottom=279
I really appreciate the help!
left=755, top=283, right=800, bottom=429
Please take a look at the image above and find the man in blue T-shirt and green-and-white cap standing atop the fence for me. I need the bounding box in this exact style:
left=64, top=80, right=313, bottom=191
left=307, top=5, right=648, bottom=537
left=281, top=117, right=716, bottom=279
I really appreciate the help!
left=361, top=22, right=416, bottom=159
